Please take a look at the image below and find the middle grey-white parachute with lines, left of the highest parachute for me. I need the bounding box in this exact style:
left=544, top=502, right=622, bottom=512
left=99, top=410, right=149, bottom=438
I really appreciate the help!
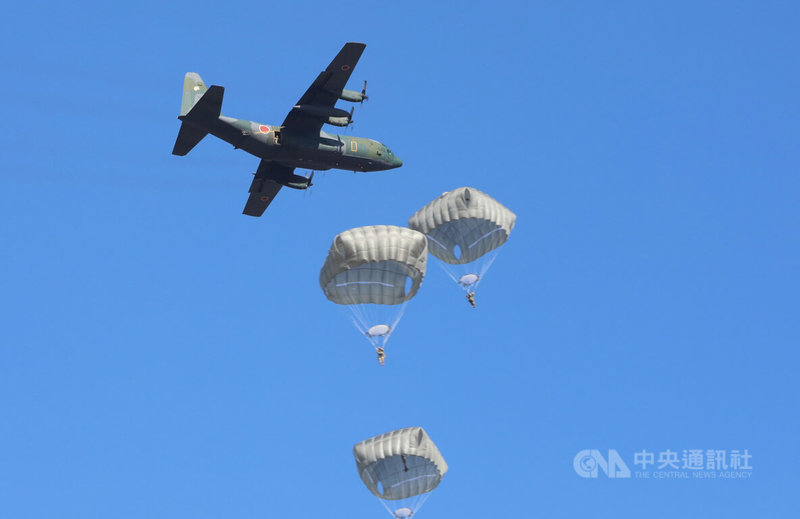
left=319, top=225, right=428, bottom=348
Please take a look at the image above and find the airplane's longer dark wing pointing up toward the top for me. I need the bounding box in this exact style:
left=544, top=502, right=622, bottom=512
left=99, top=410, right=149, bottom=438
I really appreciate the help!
left=283, top=43, right=366, bottom=134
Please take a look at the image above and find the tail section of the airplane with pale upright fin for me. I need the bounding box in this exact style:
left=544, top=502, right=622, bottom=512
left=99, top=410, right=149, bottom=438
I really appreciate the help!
left=172, top=72, right=225, bottom=155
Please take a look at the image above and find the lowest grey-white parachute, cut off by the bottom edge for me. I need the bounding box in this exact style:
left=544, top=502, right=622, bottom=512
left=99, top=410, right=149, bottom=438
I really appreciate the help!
left=353, top=427, right=447, bottom=519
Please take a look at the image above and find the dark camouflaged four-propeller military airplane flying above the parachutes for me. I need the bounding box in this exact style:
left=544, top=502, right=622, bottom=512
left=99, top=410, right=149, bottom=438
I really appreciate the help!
left=172, top=43, right=403, bottom=216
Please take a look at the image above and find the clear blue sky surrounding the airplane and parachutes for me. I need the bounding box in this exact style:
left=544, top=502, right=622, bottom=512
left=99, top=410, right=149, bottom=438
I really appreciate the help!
left=0, top=1, right=800, bottom=519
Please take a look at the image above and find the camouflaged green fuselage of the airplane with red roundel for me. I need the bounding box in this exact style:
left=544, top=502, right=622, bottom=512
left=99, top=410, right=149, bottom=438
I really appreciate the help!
left=185, top=115, right=403, bottom=171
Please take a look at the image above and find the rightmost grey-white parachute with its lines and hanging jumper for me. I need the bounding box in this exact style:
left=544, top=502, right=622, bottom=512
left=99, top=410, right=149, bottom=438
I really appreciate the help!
left=408, top=187, right=517, bottom=307
